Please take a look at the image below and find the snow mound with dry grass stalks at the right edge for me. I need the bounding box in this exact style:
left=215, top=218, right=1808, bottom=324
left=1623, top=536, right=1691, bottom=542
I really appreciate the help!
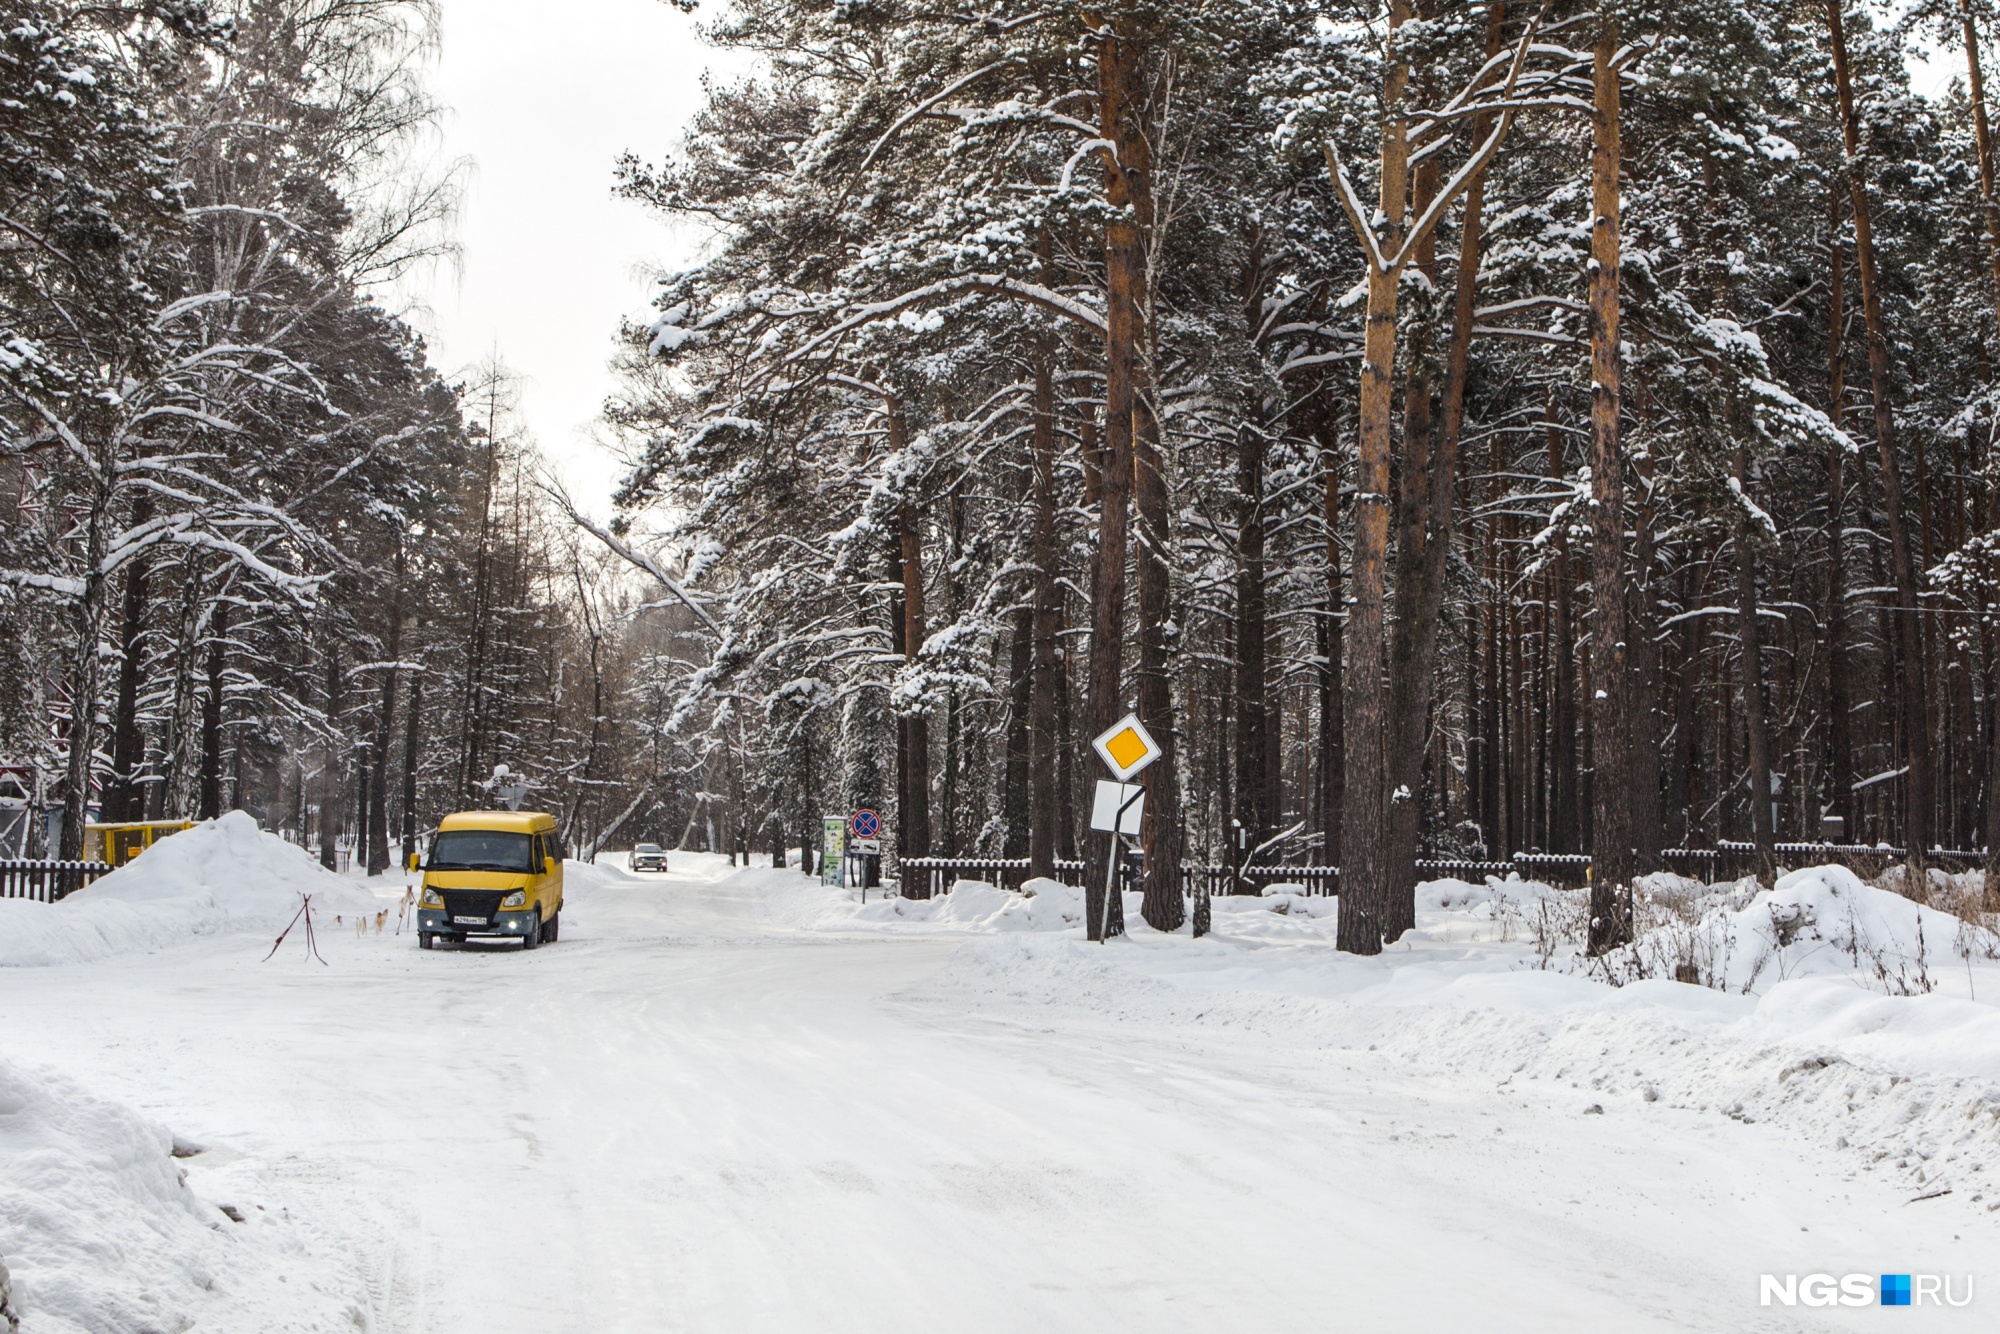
left=1604, top=866, right=2000, bottom=996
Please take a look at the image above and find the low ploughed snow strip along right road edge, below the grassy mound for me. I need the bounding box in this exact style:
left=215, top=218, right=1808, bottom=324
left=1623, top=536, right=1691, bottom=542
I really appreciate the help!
left=928, top=920, right=2000, bottom=1212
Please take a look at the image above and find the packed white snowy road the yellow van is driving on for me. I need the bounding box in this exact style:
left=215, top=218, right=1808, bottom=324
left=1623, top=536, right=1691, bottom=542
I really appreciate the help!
left=0, top=856, right=1994, bottom=1334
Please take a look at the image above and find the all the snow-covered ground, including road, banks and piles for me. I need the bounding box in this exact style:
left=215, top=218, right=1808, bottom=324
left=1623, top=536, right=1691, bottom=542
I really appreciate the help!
left=0, top=830, right=2000, bottom=1334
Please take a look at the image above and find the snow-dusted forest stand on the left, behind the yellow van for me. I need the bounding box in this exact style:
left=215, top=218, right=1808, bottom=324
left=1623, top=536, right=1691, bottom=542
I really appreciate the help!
left=0, top=0, right=716, bottom=870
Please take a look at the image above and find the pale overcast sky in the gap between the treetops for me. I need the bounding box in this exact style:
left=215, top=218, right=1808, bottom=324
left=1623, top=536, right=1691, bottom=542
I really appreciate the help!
left=394, top=0, right=748, bottom=510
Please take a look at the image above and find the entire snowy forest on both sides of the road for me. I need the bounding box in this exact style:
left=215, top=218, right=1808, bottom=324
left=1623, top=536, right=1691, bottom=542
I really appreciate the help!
left=11, top=0, right=2000, bottom=952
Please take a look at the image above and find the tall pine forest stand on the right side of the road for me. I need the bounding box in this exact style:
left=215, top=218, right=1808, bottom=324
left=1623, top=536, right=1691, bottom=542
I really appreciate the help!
left=614, top=0, right=2000, bottom=952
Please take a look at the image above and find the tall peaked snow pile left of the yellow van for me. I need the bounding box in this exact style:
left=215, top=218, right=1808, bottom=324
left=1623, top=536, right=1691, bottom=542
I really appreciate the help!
left=0, top=810, right=384, bottom=966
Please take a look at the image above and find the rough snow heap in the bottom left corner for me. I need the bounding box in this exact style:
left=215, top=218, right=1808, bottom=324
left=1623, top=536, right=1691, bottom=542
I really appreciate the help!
left=0, top=1060, right=230, bottom=1334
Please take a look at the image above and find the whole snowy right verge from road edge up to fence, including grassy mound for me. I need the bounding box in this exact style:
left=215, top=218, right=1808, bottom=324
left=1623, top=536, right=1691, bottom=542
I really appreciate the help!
left=752, top=866, right=2000, bottom=1210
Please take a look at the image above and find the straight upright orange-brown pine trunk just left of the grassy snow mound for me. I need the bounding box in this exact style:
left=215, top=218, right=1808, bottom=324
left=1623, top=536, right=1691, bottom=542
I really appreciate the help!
left=1588, top=14, right=1636, bottom=954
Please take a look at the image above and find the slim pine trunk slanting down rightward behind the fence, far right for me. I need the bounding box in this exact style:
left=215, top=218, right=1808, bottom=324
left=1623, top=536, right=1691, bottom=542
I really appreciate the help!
left=1826, top=0, right=1930, bottom=884
